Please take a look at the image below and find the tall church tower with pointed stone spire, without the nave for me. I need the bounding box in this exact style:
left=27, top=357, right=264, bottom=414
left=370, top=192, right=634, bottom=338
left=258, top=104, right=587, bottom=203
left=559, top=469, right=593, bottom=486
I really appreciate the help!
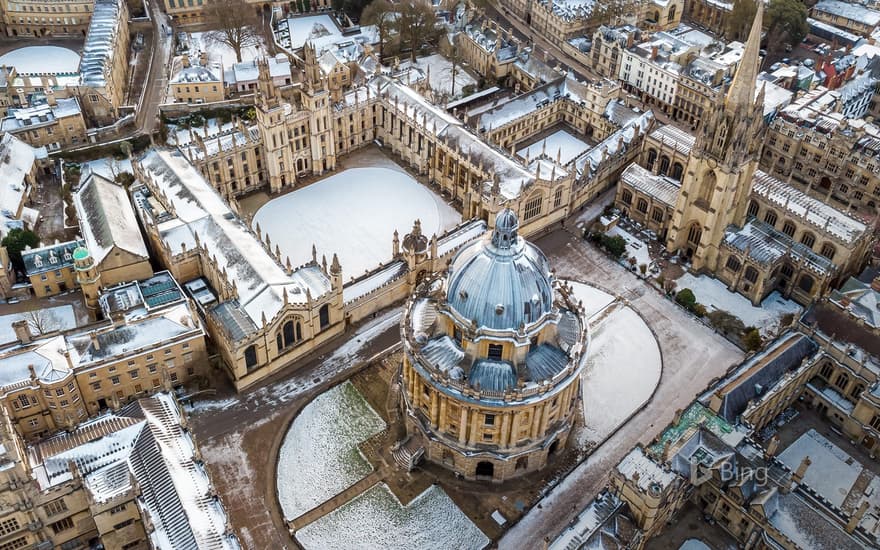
left=666, top=2, right=765, bottom=272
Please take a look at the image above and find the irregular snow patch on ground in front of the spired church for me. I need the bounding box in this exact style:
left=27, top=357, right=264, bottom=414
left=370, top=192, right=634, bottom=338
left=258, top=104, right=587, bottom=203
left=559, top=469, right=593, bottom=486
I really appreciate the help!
left=677, top=273, right=802, bottom=335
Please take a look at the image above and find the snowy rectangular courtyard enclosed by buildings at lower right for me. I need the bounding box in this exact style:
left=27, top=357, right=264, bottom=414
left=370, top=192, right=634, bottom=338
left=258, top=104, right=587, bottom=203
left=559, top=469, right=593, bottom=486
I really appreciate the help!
left=779, top=429, right=862, bottom=508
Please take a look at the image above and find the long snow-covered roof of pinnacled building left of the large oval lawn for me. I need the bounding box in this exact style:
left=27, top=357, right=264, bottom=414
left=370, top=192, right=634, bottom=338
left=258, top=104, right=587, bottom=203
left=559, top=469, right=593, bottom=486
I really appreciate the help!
left=138, top=149, right=330, bottom=334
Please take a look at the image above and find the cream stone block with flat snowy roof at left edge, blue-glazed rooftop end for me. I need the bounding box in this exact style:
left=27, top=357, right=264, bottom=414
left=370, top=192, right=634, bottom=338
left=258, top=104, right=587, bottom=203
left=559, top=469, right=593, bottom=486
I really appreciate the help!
left=0, top=272, right=209, bottom=440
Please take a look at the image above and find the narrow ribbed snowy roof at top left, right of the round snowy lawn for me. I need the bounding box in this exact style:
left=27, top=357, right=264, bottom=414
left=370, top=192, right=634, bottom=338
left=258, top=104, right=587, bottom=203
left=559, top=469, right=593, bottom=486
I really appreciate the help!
left=79, top=0, right=122, bottom=88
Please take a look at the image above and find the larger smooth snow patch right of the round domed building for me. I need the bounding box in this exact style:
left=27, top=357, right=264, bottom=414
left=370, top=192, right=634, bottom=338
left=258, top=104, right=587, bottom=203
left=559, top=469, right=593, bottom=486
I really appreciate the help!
left=581, top=300, right=662, bottom=442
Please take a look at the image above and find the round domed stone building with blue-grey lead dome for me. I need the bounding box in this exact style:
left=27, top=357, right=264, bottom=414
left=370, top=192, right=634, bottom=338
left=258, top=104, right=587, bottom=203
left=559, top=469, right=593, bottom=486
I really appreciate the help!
left=401, top=210, right=589, bottom=481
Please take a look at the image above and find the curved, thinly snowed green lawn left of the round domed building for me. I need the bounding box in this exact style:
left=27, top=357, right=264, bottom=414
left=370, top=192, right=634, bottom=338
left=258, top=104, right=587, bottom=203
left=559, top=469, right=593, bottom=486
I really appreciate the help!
left=278, top=382, right=385, bottom=520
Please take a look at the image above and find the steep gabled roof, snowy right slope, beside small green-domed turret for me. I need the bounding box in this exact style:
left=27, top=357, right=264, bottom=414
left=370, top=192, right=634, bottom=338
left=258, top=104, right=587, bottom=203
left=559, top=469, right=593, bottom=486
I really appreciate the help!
left=73, top=172, right=149, bottom=263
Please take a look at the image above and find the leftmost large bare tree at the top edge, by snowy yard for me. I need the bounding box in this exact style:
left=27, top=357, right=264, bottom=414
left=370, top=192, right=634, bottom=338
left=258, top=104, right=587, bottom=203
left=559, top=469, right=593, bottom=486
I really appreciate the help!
left=204, top=0, right=261, bottom=63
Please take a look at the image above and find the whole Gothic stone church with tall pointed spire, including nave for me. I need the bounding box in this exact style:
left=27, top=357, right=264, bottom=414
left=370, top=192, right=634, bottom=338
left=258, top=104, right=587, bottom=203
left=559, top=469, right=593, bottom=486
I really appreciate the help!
left=616, top=6, right=873, bottom=304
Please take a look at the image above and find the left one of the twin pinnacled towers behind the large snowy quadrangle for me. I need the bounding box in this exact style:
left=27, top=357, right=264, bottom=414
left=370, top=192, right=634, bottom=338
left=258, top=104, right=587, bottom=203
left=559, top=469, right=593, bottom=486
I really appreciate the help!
left=256, top=59, right=295, bottom=193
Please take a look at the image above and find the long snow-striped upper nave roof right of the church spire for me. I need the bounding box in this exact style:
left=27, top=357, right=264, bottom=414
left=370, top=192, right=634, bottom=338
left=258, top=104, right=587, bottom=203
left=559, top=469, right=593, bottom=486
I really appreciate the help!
left=752, top=170, right=868, bottom=246
